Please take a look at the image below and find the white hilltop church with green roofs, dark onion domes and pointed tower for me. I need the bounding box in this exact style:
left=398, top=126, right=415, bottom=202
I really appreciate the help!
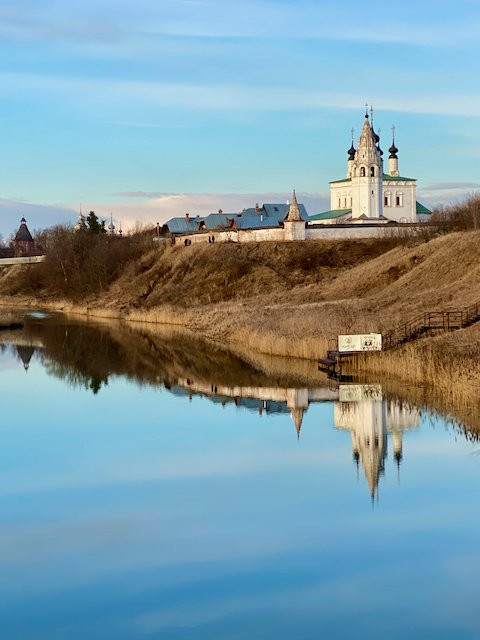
left=308, top=109, right=431, bottom=224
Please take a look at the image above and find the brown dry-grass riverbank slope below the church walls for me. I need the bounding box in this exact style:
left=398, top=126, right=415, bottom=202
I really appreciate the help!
left=0, top=232, right=480, bottom=386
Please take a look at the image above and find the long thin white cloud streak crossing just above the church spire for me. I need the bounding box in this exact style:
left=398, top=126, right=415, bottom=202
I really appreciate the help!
left=4, top=72, right=480, bottom=118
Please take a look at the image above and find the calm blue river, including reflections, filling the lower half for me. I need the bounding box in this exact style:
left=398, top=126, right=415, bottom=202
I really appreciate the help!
left=0, top=317, right=480, bottom=640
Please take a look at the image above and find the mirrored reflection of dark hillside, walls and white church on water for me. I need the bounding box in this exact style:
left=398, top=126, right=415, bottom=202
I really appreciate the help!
left=0, top=316, right=468, bottom=500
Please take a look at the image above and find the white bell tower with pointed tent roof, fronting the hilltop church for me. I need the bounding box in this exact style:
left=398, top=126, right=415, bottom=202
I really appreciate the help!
left=350, top=105, right=383, bottom=219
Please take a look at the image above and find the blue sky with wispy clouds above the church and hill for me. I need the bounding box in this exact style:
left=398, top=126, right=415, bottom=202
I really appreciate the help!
left=0, top=0, right=480, bottom=237
